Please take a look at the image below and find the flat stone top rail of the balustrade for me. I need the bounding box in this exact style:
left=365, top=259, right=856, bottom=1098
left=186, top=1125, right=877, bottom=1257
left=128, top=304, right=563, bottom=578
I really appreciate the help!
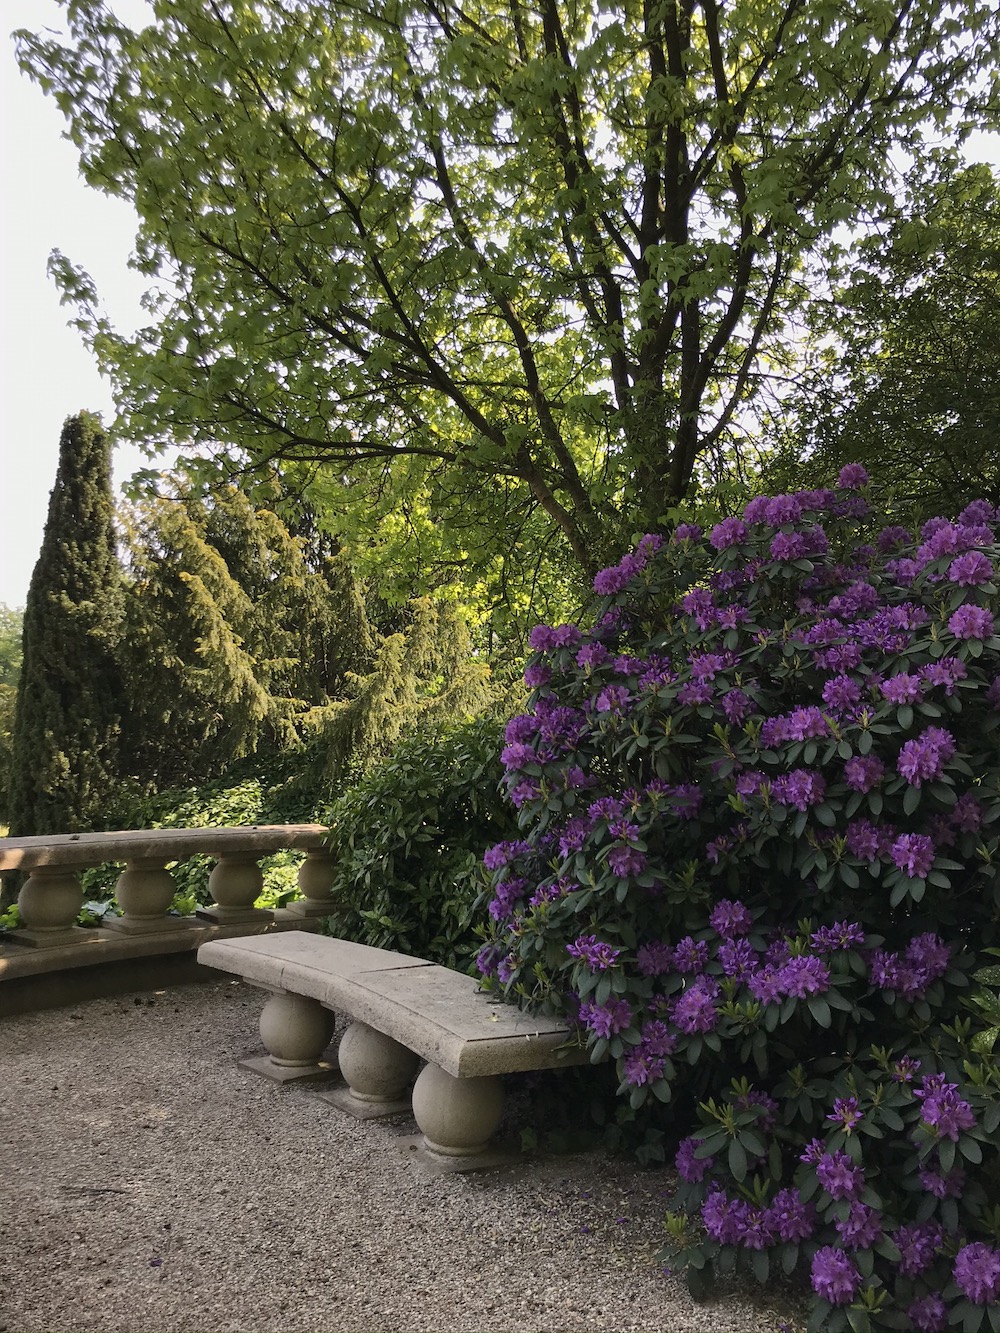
left=0, top=824, right=328, bottom=870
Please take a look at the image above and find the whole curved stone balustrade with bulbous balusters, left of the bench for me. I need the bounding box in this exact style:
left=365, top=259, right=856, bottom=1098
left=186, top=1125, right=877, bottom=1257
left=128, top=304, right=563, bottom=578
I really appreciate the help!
left=0, top=824, right=335, bottom=1012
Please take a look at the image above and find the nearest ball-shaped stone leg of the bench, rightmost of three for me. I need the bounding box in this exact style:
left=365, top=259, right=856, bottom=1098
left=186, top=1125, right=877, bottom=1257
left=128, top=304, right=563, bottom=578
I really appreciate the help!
left=413, top=1065, right=504, bottom=1170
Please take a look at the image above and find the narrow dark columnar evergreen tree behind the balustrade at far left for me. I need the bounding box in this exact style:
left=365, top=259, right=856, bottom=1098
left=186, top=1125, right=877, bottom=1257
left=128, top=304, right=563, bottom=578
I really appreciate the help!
left=9, top=412, right=123, bottom=836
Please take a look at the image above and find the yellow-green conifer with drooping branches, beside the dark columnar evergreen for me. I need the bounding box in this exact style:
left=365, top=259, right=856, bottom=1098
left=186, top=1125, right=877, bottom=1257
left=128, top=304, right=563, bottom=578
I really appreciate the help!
left=120, top=481, right=489, bottom=788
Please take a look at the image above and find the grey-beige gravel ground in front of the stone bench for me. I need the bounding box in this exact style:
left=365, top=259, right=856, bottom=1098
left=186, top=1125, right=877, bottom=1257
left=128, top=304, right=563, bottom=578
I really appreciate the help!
left=0, top=981, right=792, bottom=1333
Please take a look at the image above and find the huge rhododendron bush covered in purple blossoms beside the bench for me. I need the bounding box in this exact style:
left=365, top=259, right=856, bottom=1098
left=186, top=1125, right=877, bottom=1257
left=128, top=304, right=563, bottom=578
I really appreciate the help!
left=479, top=465, right=1000, bottom=1333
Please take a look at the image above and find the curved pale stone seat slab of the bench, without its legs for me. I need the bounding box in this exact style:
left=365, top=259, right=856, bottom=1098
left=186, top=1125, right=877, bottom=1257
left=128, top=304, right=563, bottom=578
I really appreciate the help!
left=197, top=930, right=588, bottom=1078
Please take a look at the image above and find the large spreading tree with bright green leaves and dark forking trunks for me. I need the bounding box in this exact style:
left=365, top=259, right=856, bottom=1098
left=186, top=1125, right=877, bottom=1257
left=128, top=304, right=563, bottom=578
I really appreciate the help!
left=20, top=0, right=1000, bottom=589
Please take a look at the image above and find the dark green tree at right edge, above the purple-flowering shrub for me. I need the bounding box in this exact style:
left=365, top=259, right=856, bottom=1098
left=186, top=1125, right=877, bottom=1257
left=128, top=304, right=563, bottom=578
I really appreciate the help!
left=768, top=164, right=1000, bottom=519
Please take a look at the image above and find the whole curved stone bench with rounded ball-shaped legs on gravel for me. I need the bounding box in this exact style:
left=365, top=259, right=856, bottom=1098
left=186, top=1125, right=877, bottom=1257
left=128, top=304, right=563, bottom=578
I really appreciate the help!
left=197, top=930, right=588, bottom=1169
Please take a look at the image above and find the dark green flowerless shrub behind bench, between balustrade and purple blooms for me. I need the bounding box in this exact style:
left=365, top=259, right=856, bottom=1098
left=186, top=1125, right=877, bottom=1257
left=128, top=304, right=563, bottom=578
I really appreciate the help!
left=327, top=718, right=515, bottom=969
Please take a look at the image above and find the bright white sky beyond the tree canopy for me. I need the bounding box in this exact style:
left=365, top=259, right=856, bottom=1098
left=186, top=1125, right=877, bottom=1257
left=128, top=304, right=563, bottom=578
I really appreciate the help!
left=0, top=0, right=1000, bottom=607
